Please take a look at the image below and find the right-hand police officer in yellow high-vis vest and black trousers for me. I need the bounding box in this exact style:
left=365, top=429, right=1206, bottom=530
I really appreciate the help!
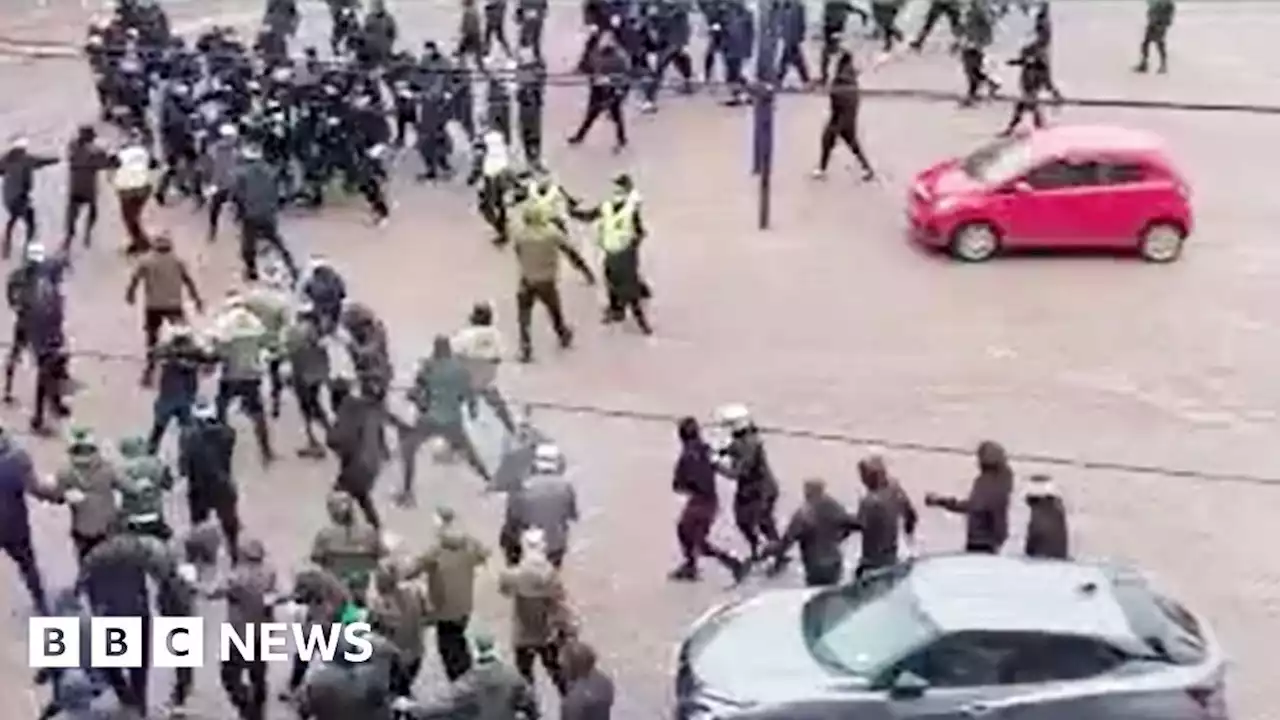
left=568, top=174, right=653, bottom=334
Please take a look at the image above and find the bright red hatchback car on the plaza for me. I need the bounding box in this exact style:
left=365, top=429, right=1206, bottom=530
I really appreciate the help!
left=908, top=126, right=1193, bottom=263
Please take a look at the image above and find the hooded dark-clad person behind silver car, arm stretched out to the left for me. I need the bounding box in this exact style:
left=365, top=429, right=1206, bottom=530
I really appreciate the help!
left=924, top=441, right=1014, bottom=555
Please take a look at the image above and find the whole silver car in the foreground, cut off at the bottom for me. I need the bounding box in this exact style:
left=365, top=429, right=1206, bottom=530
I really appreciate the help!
left=676, top=555, right=1229, bottom=720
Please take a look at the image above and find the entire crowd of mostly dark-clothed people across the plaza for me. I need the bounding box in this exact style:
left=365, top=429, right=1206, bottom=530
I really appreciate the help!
left=0, top=0, right=1174, bottom=720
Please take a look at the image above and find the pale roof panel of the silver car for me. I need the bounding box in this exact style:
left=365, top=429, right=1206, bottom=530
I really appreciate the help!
left=908, top=553, right=1137, bottom=644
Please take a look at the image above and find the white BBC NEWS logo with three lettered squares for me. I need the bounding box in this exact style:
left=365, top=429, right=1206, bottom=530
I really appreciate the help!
left=27, top=616, right=374, bottom=667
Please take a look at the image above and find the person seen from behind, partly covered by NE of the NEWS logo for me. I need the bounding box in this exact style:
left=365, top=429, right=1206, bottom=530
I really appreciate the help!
left=209, top=539, right=276, bottom=720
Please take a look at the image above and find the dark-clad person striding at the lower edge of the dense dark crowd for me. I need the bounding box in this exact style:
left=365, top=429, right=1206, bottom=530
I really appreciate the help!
left=230, top=142, right=298, bottom=282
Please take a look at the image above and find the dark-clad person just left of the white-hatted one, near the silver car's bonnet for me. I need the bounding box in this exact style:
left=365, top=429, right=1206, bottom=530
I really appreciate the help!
left=669, top=418, right=746, bottom=582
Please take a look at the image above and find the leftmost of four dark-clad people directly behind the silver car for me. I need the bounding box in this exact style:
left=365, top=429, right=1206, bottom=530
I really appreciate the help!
left=764, top=478, right=858, bottom=587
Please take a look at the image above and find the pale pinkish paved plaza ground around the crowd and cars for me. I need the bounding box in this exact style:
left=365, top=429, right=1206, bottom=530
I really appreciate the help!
left=0, top=0, right=1280, bottom=720
